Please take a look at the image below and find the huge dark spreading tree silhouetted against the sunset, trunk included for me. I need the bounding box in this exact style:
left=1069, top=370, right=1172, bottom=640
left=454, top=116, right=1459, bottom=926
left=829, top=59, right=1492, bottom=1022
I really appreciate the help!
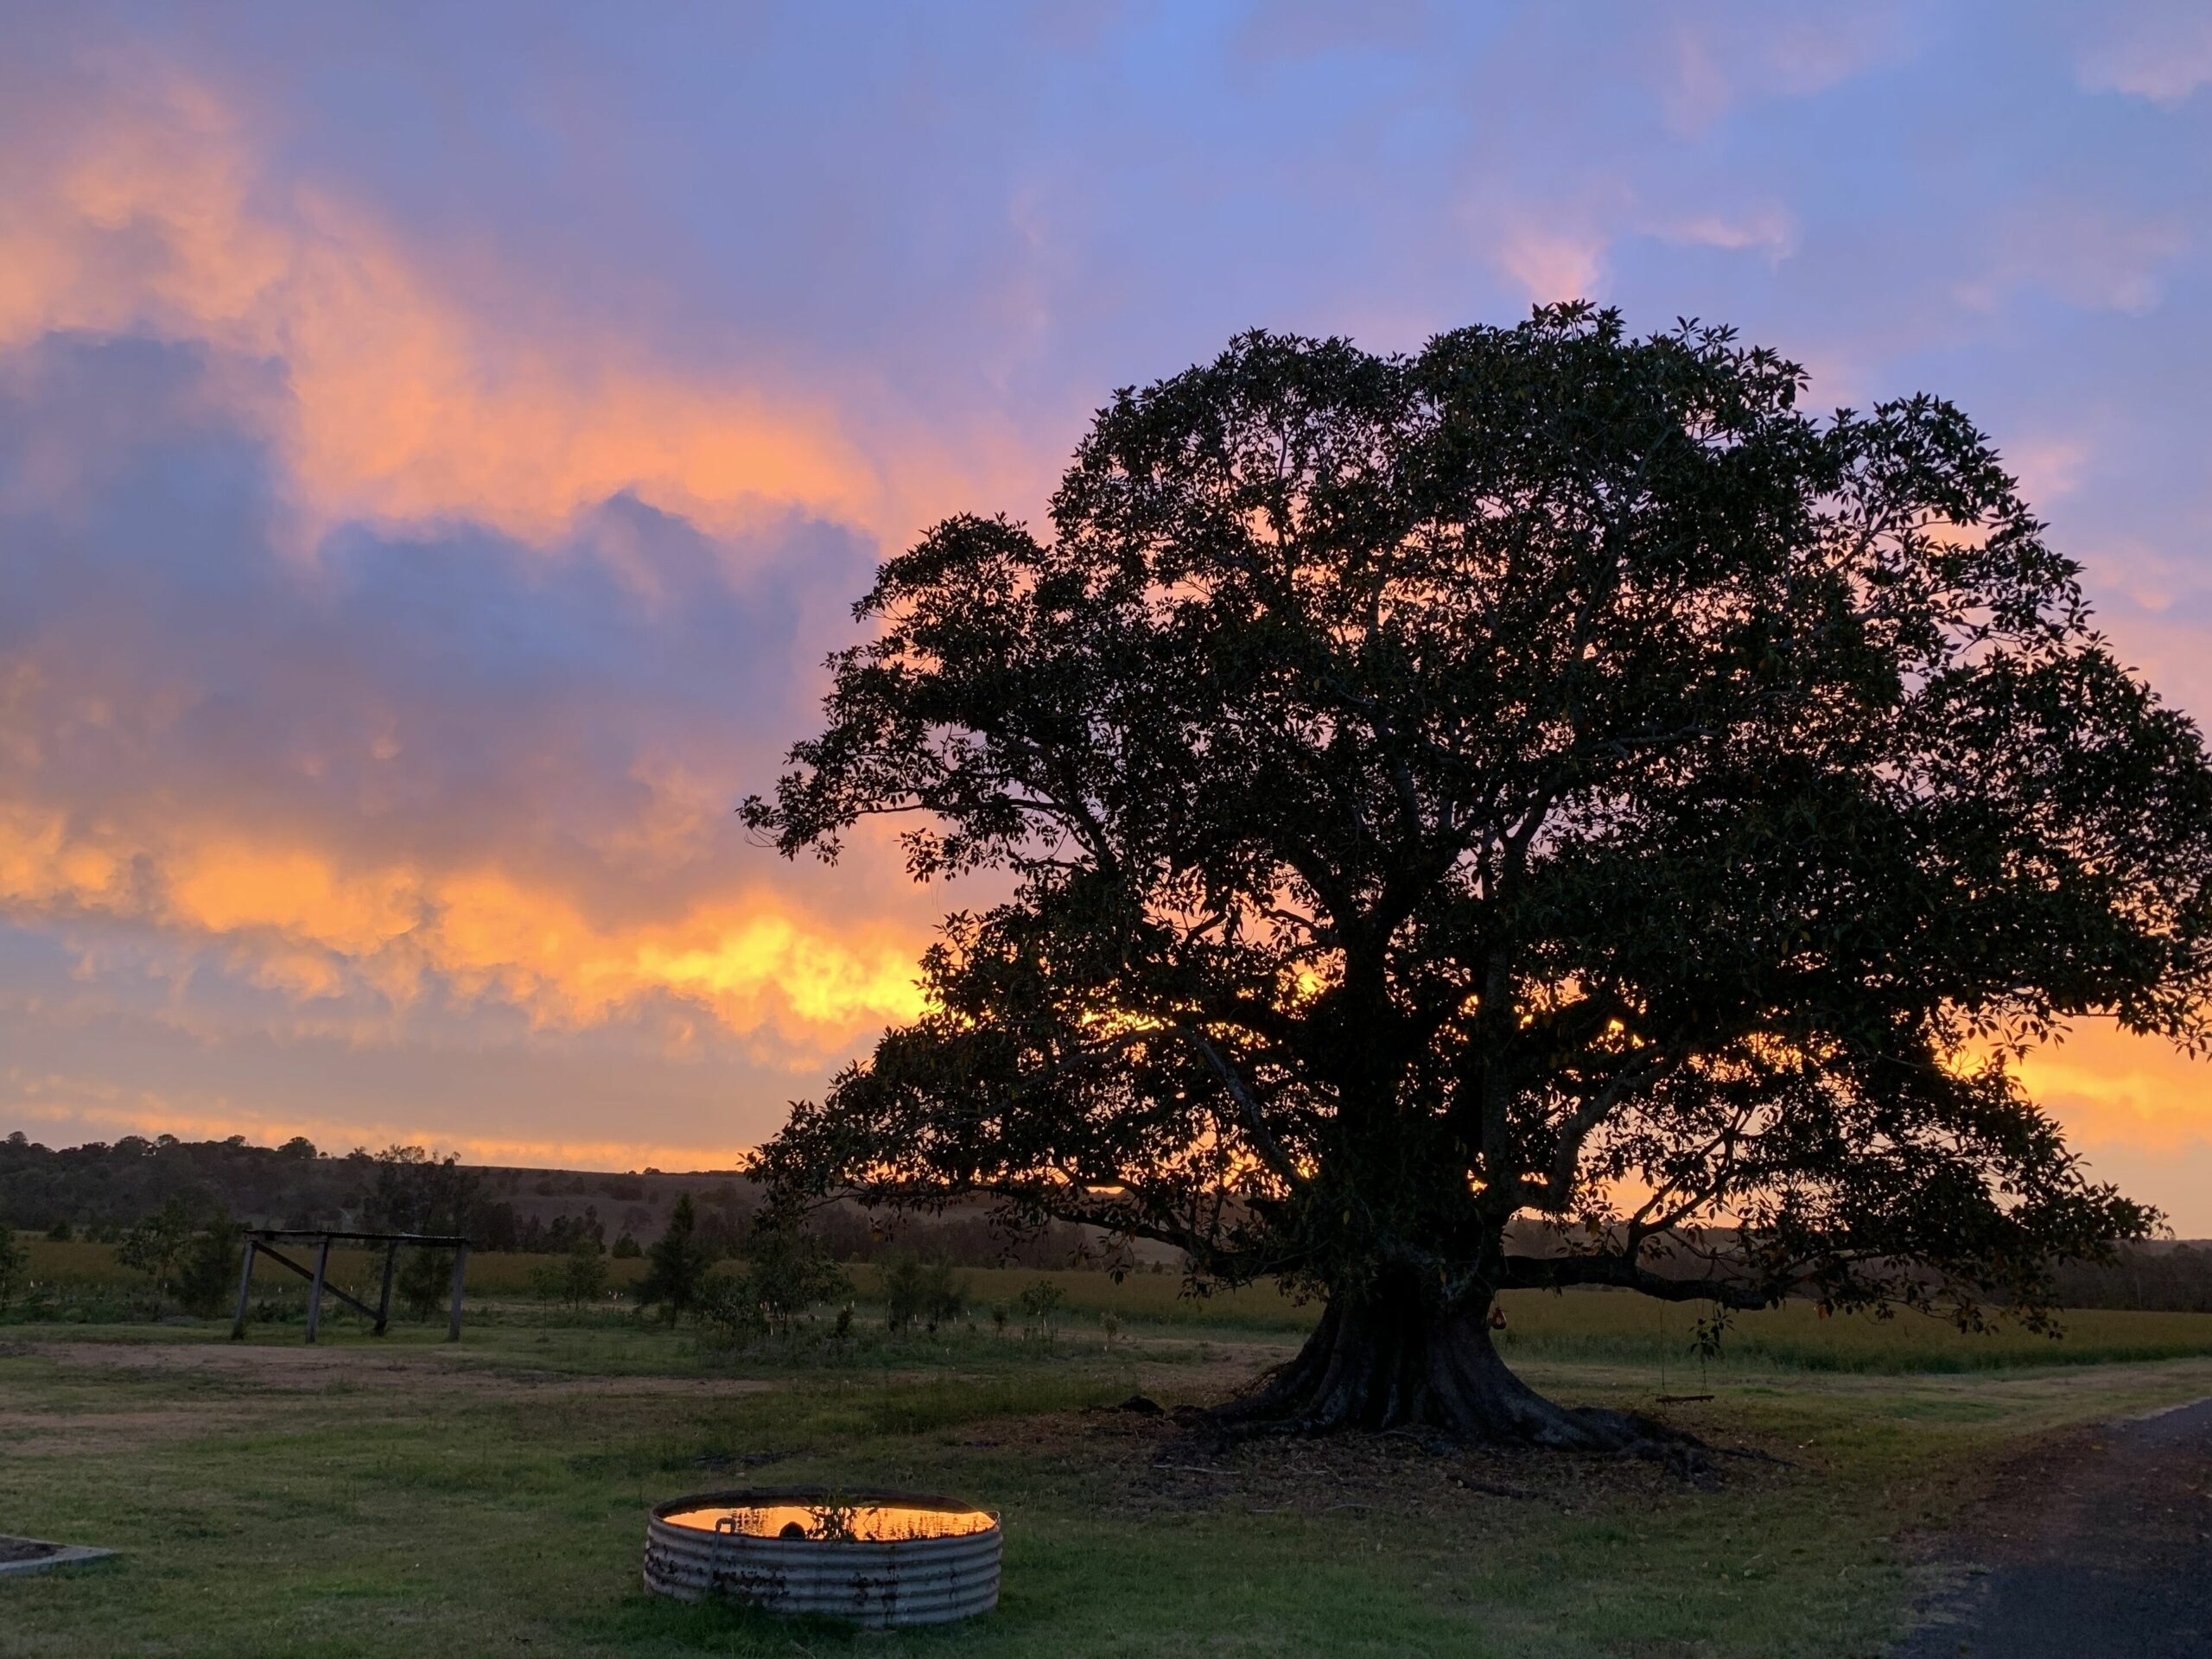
left=746, top=305, right=2212, bottom=1446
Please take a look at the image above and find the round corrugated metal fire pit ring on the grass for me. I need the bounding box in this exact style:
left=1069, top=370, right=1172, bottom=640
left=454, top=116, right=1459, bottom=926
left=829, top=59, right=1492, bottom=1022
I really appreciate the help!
left=646, top=1486, right=1004, bottom=1630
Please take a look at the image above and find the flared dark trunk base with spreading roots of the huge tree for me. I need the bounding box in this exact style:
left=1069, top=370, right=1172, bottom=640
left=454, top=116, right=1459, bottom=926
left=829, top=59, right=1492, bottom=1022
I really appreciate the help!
left=1214, top=1281, right=1701, bottom=1465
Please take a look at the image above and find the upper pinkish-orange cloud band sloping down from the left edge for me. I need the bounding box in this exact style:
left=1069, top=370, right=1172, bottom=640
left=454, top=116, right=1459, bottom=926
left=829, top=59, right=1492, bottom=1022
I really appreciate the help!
left=0, top=69, right=885, bottom=537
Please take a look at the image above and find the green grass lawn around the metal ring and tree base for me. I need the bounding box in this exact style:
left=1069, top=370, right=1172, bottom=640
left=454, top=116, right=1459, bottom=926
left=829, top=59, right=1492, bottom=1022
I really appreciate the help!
left=13, top=1274, right=2212, bottom=1659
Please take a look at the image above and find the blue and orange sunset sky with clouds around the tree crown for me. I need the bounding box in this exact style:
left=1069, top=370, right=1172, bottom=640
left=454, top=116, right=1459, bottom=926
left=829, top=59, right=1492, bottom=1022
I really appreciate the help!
left=0, top=0, right=2212, bottom=1234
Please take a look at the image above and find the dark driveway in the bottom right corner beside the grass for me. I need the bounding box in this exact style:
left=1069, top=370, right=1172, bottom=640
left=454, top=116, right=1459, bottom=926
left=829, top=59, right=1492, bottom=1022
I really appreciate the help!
left=1893, top=1400, right=2212, bottom=1659
